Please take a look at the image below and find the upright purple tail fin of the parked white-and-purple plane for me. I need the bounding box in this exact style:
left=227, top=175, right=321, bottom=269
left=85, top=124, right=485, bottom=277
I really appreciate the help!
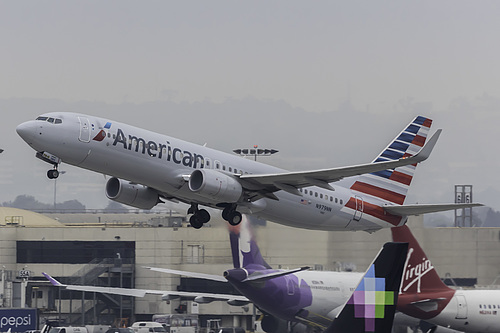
left=229, top=214, right=271, bottom=269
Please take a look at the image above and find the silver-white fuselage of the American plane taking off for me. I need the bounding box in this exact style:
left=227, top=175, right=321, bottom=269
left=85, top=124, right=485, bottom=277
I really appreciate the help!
left=17, top=112, right=406, bottom=231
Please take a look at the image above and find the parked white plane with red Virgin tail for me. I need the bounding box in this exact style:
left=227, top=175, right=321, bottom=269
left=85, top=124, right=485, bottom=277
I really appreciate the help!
left=391, top=226, right=500, bottom=333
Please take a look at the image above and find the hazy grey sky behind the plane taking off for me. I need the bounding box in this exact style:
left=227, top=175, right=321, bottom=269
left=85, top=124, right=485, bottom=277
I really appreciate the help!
left=0, top=0, right=500, bottom=213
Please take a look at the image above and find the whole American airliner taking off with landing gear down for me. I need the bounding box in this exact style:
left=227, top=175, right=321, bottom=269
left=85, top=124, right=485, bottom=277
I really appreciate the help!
left=17, top=112, right=471, bottom=231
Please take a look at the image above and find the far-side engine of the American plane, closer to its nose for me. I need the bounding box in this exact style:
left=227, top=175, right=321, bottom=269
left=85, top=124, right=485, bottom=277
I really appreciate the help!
left=106, top=177, right=159, bottom=209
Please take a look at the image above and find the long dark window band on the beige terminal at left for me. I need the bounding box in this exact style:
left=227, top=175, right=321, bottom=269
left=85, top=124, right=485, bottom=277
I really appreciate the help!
left=16, top=241, right=135, bottom=264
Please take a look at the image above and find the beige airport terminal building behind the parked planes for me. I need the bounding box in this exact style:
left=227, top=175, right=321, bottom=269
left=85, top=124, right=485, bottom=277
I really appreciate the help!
left=0, top=207, right=500, bottom=329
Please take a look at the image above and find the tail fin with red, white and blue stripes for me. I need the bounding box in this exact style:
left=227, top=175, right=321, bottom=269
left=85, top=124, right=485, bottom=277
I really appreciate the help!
left=351, top=116, right=432, bottom=205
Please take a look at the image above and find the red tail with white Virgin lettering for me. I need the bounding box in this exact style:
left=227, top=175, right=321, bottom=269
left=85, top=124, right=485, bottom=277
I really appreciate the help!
left=391, top=225, right=455, bottom=319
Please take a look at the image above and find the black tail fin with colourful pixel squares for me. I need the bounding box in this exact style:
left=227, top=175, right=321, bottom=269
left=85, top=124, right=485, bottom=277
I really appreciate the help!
left=326, top=243, right=408, bottom=333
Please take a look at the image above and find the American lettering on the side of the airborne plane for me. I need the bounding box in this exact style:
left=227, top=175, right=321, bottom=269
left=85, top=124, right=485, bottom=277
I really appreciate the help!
left=110, top=128, right=205, bottom=169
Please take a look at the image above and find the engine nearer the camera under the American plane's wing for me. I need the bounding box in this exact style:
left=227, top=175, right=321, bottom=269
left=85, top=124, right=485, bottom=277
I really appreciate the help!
left=189, top=169, right=243, bottom=203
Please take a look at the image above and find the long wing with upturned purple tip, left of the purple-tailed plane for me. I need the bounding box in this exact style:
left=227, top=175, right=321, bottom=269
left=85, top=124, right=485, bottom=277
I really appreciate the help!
left=42, top=273, right=250, bottom=305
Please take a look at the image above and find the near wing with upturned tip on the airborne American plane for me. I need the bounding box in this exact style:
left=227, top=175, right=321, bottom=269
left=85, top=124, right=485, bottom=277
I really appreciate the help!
left=239, top=129, right=441, bottom=195
